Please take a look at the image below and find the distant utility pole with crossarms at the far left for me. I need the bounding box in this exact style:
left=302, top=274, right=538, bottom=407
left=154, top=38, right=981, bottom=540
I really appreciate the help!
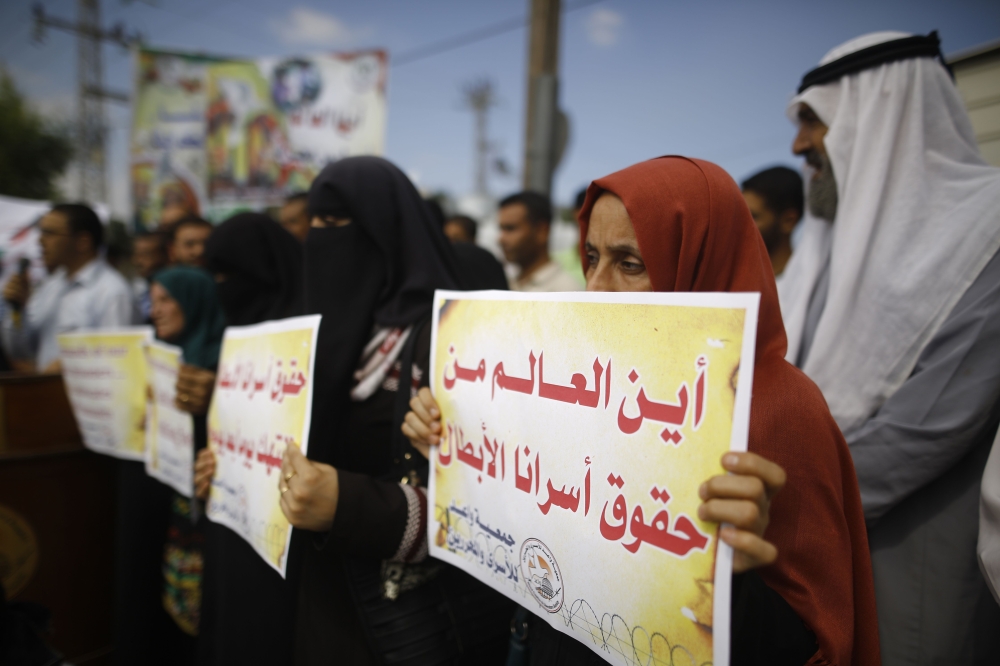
left=34, top=0, right=141, bottom=202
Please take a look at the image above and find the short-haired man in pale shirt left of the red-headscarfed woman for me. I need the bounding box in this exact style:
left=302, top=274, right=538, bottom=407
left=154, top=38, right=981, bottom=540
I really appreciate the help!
left=498, top=192, right=583, bottom=291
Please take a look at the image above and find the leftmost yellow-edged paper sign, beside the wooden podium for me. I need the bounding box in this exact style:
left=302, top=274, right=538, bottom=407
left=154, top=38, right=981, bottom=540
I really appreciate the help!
left=57, top=326, right=153, bottom=460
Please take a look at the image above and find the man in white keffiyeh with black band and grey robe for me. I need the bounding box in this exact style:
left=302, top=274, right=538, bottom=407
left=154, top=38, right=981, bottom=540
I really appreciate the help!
left=779, top=32, right=1000, bottom=664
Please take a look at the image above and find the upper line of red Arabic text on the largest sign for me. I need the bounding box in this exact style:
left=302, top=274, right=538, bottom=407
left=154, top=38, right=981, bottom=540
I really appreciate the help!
left=442, top=346, right=708, bottom=446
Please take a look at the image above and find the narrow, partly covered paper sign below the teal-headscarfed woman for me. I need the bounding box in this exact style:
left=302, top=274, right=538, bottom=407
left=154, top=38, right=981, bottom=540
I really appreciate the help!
left=146, top=341, right=194, bottom=497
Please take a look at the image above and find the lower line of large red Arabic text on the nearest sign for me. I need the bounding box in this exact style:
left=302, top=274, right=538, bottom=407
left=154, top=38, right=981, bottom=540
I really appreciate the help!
left=438, top=423, right=708, bottom=557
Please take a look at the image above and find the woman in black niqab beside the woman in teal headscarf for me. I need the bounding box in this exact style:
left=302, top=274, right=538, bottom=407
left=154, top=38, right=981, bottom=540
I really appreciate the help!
left=198, top=213, right=303, bottom=666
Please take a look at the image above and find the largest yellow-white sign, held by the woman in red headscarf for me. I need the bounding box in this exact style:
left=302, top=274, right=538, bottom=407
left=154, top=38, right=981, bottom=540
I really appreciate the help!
left=428, top=291, right=759, bottom=664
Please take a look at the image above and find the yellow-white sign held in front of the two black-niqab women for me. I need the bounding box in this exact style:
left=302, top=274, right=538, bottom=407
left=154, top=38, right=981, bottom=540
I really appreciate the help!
left=207, top=315, right=320, bottom=577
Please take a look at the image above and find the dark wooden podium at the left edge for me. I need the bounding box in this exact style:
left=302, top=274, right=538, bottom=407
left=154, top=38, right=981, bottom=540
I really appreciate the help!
left=0, top=373, right=117, bottom=666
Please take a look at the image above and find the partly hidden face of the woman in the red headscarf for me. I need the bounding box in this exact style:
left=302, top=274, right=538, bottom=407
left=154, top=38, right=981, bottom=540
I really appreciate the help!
left=584, top=192, right=653, bottom=291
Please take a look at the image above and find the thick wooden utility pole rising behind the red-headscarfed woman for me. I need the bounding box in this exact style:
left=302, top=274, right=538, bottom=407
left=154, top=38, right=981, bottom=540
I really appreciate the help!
left=524, top=0, right=569, bottom=194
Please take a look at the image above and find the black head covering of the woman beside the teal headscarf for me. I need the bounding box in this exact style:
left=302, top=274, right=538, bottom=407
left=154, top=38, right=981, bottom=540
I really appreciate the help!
left=199, top=213, right=303, bottom=326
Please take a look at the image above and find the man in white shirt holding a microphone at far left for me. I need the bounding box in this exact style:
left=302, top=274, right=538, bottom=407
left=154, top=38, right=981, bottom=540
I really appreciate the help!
left=3, top=204, right=137, bottom=372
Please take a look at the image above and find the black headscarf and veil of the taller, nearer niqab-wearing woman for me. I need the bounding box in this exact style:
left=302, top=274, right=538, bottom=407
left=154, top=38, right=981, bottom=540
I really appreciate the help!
left=305, top=157, right=465, bottom=463
